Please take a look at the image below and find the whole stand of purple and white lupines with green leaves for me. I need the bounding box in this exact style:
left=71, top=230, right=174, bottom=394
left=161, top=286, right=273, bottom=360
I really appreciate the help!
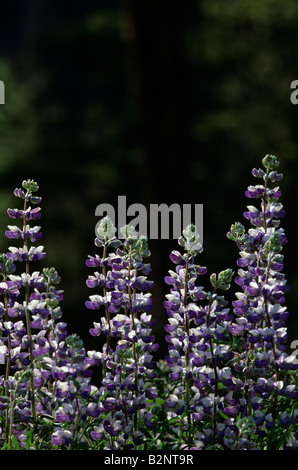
left=0, top=155, right=298, bottom=450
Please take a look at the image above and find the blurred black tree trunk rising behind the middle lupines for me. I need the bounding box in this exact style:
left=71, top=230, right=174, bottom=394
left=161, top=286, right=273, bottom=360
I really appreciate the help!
left=124, top=0, right=196, bottom=353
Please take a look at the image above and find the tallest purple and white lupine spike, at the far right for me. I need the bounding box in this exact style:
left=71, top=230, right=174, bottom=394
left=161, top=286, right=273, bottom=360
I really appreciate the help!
left=228, top=155, right=297, bottom=448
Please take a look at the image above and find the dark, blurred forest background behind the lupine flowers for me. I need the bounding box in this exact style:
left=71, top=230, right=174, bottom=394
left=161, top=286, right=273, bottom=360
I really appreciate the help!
left=0, top=0, right=298, bottom=360
